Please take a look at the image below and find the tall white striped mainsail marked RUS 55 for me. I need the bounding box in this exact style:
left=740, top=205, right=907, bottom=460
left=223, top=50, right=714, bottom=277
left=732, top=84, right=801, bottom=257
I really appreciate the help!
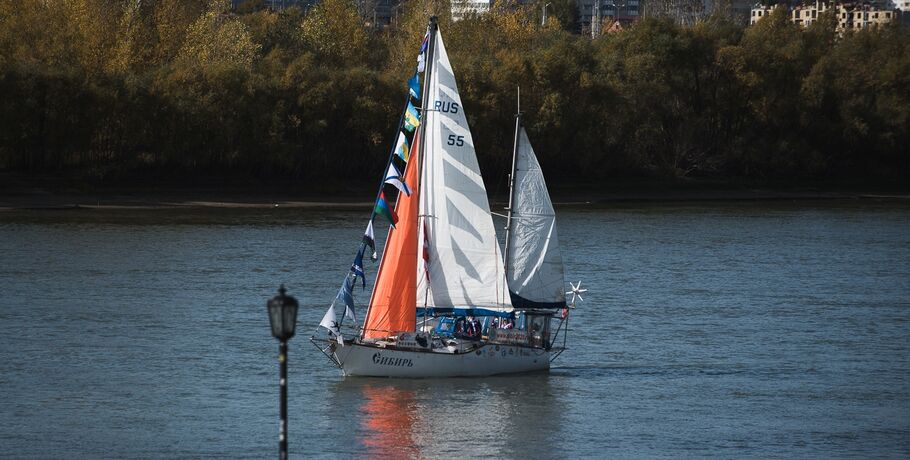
left=417, top=33, right=512, bottom=310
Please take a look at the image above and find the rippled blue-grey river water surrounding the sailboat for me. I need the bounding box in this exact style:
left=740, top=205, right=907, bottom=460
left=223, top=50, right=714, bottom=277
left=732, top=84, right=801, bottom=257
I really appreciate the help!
left=0, top=200, right=910, bottom=459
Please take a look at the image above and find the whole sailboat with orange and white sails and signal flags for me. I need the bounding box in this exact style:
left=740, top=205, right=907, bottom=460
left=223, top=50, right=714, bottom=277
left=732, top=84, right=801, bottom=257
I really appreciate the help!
left=311, top=17, right=575, bottom=377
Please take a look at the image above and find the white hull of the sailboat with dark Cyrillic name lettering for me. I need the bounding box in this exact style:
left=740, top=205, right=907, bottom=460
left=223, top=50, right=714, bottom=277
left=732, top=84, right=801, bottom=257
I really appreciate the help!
left=333, top=343, right=550, bottom=378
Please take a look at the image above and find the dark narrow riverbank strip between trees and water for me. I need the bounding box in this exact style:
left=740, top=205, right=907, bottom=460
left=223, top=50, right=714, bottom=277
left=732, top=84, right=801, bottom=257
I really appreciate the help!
left=0, top=174, right=910, bottom=210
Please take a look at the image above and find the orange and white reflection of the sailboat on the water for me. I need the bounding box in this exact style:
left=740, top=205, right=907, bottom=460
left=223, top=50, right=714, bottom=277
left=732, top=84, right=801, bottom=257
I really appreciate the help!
left=333, top=374, right=561, bottom=458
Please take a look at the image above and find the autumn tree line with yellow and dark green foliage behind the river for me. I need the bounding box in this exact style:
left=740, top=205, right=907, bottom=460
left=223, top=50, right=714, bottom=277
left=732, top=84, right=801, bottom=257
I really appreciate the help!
left=0, top=0, right=910, bottom=187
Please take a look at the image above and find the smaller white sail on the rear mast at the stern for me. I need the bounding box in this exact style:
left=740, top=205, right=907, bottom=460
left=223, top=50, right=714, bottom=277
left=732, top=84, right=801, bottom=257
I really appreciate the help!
left=506, top=127, right=566, bottom=308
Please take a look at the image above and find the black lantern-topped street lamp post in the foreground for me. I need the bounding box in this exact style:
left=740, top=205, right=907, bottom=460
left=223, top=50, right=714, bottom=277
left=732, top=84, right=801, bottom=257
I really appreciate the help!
left=266, top=284, right=298, bottom=460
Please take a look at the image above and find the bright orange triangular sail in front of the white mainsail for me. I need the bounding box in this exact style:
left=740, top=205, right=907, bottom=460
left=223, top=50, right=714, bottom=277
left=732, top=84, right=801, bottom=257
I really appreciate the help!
left=363, top=130, right=420, bottom=339
